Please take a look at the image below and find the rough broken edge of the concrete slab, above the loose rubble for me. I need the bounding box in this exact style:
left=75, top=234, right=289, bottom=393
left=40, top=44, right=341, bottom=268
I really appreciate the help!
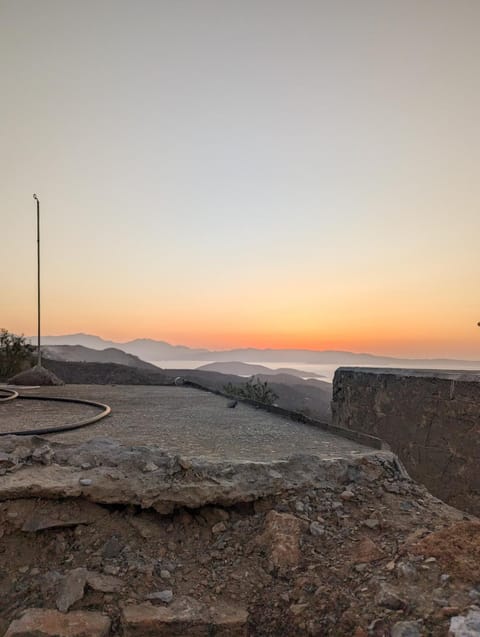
left=0, top=436, right=404, bottom=514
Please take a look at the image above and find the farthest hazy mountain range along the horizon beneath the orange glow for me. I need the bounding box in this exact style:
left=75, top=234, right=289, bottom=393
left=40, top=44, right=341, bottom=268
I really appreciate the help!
left=30, top=334, right=480, bottom=369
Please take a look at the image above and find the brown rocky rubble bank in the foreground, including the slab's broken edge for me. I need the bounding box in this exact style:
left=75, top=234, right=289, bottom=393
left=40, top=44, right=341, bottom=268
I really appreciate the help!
left=0, top=437, right=480, bottom=637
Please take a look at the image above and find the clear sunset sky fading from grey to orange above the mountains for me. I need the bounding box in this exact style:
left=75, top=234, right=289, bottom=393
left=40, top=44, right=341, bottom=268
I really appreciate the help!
left=0, top=0, right=480, bottom=359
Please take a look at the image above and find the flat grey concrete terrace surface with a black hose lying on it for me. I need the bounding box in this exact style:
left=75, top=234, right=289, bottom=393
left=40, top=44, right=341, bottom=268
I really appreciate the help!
left=0, top=385, right=372, bottom=462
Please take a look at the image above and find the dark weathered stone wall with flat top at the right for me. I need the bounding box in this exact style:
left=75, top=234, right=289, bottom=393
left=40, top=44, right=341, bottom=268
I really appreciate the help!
left=332, top=367, right=480, bottom=515
